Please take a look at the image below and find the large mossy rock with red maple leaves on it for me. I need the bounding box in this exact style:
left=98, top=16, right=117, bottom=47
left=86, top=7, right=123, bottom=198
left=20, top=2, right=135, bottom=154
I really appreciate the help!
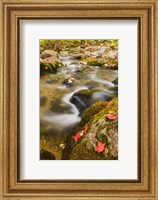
left=70, top=98, right=118, bottom=160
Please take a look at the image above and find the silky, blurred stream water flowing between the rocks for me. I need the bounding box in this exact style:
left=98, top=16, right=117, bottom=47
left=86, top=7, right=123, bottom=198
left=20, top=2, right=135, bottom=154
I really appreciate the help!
left=40, top=51, right=118, bottom=157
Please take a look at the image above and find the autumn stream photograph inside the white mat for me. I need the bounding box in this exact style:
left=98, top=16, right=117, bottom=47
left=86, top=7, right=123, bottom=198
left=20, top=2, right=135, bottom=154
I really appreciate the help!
left=39, top=39, right=118, bottom=160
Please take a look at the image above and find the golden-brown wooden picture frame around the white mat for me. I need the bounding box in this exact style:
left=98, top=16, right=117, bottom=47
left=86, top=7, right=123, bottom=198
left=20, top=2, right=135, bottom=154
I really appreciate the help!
left=0, top=0, right=158, bottom=200
